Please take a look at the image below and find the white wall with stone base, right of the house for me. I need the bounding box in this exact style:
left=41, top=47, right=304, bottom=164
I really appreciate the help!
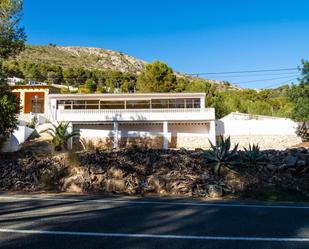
left=216, top=116, right=301, bottom=149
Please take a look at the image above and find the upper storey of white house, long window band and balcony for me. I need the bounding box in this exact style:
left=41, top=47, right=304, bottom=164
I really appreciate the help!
left=52, top=94, right=214, bottom=122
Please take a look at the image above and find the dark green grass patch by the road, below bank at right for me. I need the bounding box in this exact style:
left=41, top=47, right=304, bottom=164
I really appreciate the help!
left=239, top=186, right=309, bottom=202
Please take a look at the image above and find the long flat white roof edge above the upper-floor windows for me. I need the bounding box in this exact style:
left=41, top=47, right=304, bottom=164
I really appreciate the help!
left=48, top=92, right=206, bottom=100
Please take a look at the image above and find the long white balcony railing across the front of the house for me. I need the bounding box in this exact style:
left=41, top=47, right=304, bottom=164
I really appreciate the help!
left=55, top=108, right=215, bottom=122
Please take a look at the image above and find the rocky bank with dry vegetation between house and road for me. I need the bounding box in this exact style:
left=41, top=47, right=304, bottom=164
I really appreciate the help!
left=0, top=148, right=309, bottom=200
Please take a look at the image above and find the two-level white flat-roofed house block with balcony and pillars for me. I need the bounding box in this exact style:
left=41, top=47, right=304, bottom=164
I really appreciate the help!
left=48, top=93, right=216, bottom=149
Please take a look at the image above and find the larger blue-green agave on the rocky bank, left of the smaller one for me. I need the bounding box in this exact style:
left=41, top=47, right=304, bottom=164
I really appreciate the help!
left=204, top=136, right=238, bottom=174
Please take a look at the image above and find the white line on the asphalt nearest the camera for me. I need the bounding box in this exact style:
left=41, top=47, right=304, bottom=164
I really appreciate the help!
left=0, top=228, right=309, bottom=242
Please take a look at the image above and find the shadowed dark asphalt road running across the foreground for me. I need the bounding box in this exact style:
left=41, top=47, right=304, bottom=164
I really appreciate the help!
left=0, top=194, right=309, bottom=249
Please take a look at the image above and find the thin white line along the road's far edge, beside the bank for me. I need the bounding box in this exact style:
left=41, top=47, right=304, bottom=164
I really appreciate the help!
left=0, top=196, right=309, bottom=209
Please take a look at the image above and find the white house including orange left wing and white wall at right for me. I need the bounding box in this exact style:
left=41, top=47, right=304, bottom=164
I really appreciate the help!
left=6, top=85, right=301, bottom=152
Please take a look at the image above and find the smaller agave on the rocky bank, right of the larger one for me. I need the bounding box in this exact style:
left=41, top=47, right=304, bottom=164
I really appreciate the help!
left=243, top=144, right=267, bottom=167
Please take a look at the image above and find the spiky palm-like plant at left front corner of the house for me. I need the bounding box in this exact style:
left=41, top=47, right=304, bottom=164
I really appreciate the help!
left=40, top=122, right=80, bottom=151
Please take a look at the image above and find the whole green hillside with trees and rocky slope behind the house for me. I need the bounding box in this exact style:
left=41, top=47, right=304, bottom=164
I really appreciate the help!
left=3, top=45, right=309, bottom=120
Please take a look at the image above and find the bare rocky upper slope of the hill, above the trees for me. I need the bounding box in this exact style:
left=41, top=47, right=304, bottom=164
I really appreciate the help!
left=17, top=45, right=146, bottom=73
